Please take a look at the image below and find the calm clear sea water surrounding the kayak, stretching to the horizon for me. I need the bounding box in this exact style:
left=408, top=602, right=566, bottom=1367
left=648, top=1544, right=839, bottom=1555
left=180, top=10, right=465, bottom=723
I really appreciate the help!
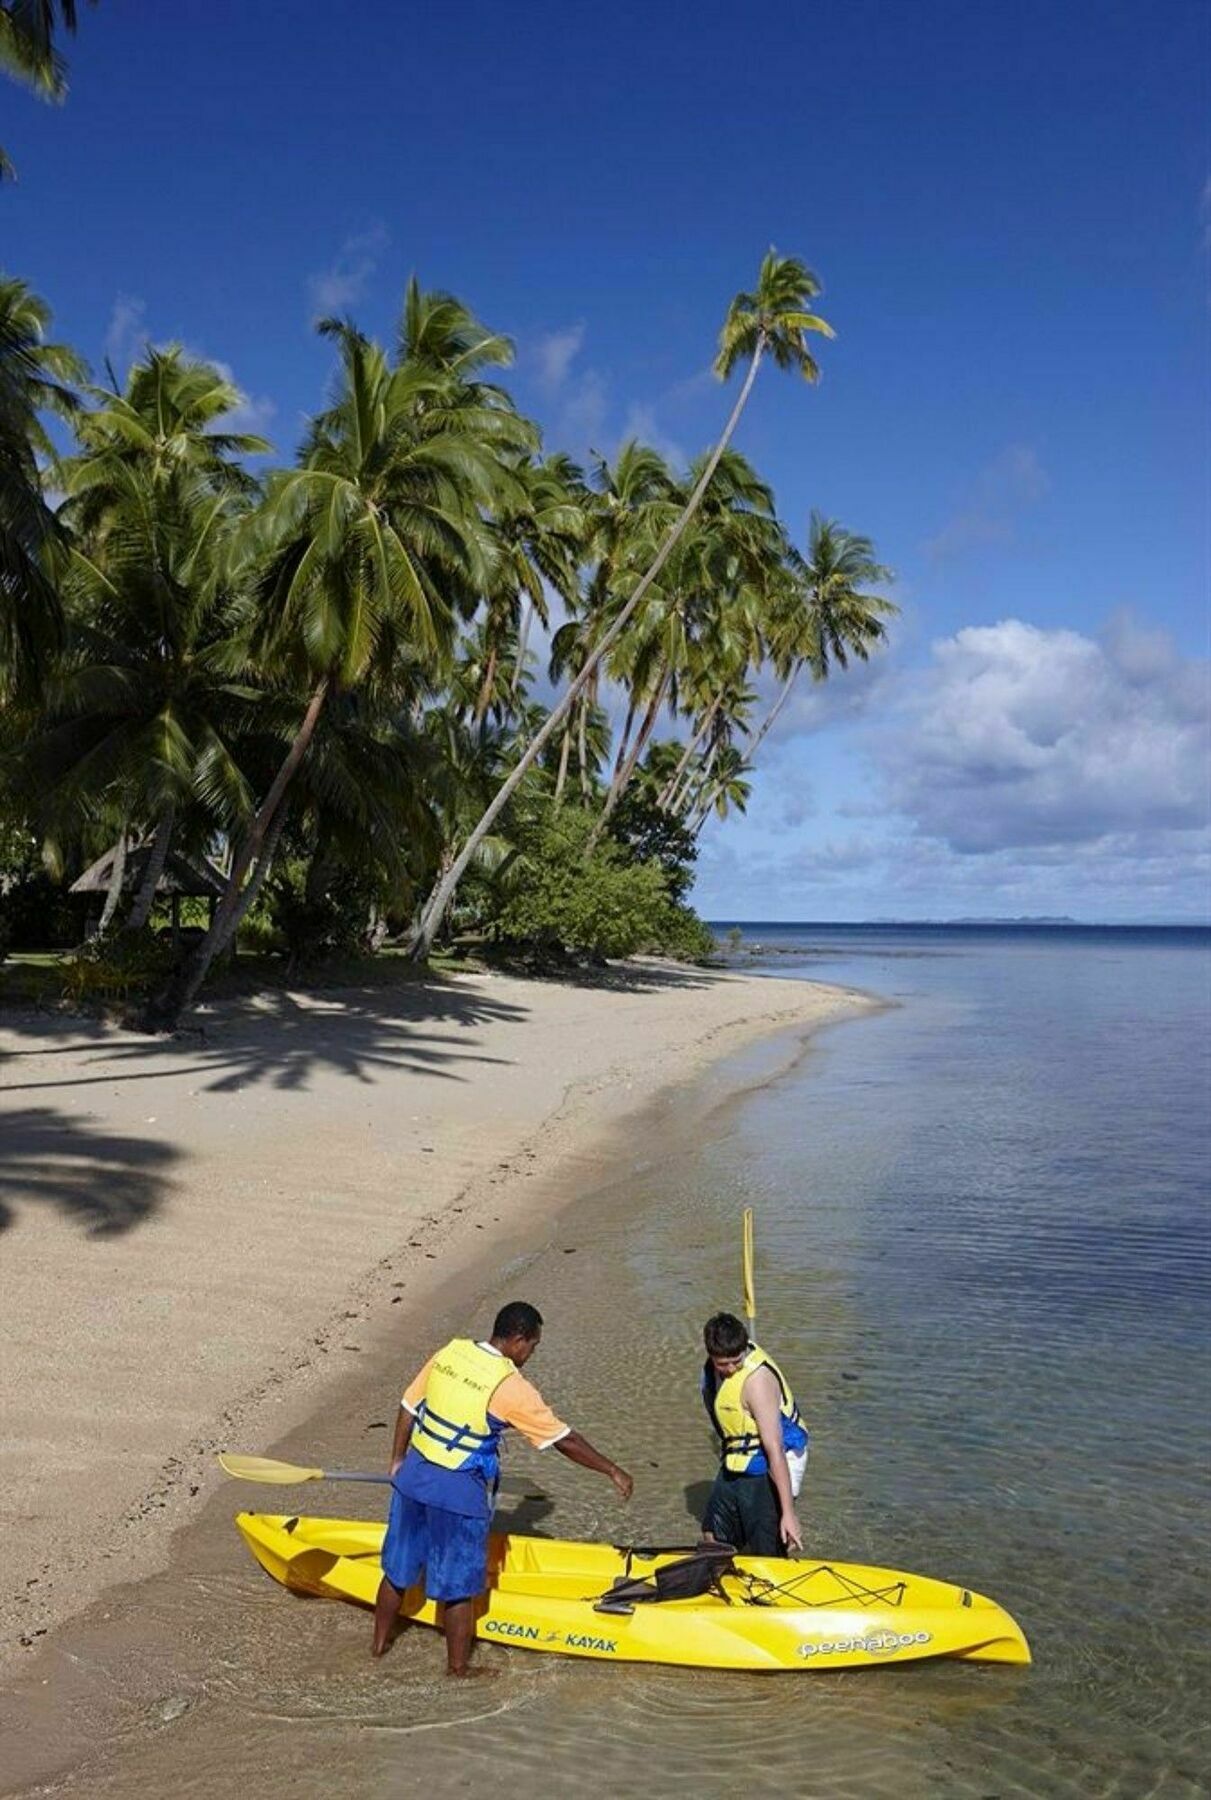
left=11, top=932, right=1211, bottom=1800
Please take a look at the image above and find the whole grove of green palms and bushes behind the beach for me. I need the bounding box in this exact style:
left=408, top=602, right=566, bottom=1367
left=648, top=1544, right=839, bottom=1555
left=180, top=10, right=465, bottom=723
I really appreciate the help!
left=0, top=250, right=896, bottom=1026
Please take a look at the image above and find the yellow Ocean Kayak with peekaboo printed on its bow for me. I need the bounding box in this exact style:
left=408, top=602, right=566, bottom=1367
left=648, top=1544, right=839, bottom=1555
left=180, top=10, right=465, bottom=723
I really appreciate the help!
left=236, top=1512, right=1031, bottom=1670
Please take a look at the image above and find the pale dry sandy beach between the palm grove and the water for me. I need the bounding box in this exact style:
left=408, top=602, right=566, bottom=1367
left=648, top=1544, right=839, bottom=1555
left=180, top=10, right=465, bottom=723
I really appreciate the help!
left=0, top=963, right=864, bottom=1665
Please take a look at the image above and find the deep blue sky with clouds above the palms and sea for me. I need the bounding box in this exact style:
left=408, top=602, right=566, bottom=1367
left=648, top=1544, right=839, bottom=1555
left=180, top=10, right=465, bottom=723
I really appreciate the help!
left=0, top=0, right=1211, bottom=918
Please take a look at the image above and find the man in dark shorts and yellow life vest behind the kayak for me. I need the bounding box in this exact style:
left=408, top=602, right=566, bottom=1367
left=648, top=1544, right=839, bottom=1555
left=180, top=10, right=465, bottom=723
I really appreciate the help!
left=702, top=1312, right=808, bottom=1557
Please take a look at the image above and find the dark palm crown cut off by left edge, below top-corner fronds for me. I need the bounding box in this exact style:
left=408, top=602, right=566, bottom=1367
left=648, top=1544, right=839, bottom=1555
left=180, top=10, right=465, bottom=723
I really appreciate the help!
left=0, top=279, right=85, bottom=697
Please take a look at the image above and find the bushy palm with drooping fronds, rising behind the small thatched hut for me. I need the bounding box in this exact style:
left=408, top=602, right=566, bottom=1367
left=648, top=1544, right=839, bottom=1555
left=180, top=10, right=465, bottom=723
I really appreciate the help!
left=27, top=356, right=259, bottom=929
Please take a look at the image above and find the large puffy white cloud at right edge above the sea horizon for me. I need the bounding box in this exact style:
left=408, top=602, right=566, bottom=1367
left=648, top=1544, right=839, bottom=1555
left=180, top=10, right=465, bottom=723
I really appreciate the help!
left=876, top=617, right=1211, bottom=855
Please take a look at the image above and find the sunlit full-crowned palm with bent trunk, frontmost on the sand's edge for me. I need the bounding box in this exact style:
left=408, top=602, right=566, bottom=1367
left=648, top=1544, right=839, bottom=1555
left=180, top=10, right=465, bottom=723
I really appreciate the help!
left=148, top=300, right=531, bottom=1026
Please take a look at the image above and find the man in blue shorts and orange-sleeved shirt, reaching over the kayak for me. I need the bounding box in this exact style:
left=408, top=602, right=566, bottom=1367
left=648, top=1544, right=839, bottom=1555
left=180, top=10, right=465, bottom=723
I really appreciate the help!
left=374, top=1300, right=633, bottom=1676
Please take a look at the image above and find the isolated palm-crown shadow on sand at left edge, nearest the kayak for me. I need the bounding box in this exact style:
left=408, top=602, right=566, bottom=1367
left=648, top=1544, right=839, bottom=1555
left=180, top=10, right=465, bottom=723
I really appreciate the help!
left=0, top=1107, right=180, bottom=1237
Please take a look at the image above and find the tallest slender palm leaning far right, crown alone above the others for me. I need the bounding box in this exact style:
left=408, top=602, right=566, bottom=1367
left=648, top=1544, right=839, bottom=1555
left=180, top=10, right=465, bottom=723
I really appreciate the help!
left=406, top=250, right=833, bottom=959
